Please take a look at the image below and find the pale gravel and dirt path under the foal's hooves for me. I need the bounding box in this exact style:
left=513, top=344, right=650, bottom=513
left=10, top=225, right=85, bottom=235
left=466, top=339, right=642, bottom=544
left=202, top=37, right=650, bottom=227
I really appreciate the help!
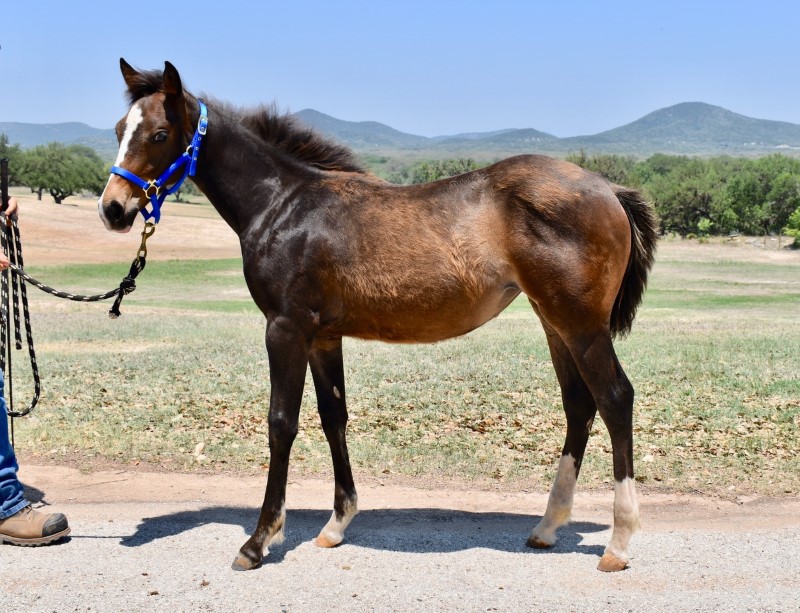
left=0, top=466, right=800, bottom=611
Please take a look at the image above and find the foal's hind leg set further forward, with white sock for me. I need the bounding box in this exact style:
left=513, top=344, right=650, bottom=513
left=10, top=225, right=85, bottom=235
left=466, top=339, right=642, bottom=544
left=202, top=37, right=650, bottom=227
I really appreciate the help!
left=527, top=316, right=597, bottom=548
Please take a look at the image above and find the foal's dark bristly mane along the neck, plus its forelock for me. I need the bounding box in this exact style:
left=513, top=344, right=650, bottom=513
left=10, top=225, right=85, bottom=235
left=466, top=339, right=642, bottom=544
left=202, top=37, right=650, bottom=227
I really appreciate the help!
left=127, top=70, right=366, bottom=174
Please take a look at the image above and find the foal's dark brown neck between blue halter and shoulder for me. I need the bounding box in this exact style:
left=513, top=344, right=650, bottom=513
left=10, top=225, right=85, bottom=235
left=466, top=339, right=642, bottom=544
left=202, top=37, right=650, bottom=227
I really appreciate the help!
left=194, top=107, right=306, bottom=235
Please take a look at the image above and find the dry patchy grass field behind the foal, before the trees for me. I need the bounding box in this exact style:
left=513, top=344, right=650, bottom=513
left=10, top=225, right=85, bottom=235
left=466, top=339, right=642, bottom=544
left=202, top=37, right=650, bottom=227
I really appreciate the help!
left=7, top=241, right=800, bottom=494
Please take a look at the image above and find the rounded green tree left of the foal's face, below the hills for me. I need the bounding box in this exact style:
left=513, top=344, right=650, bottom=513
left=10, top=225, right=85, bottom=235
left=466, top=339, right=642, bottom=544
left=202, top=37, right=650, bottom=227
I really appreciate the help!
left=19, top=143, right=107, bottom=204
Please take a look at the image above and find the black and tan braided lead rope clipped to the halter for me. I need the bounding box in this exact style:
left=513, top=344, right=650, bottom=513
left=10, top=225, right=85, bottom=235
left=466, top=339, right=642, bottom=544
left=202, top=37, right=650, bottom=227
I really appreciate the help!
left=0, top=213, right=156, bottom=447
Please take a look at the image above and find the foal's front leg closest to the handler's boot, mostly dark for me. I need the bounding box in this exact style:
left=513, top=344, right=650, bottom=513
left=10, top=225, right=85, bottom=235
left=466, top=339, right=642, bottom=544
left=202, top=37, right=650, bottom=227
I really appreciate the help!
left=233, top=319, right=308, bottom=570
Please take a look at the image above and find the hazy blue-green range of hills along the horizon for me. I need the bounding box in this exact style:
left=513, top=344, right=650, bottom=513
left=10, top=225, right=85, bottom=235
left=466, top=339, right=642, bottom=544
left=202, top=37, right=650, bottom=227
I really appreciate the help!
left=0, top=102, right=800, bottom=160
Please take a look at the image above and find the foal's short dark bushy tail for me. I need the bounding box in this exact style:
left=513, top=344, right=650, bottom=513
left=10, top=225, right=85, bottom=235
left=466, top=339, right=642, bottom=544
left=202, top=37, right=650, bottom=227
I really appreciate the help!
left=611, top=185, right=658, bottom=337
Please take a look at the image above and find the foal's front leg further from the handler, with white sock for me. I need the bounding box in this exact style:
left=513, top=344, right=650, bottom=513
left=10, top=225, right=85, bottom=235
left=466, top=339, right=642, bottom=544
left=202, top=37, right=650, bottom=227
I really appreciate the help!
left=309, top=338, right=358, bottom=547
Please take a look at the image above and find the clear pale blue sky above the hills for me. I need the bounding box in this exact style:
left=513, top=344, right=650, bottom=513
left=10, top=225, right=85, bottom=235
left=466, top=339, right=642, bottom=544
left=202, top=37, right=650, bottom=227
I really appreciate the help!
left=0, top=0, right=800, bottom=136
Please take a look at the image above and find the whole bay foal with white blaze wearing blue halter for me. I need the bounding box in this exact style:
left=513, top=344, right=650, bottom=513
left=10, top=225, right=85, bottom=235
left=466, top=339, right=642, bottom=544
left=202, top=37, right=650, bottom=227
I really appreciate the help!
left=98, top=60, right=657, bottom=571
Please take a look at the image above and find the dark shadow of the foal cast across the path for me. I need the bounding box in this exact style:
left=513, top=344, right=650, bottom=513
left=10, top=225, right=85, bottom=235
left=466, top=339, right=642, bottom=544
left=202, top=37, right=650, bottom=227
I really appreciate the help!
left=121, top=506, right=609, bottom=564
